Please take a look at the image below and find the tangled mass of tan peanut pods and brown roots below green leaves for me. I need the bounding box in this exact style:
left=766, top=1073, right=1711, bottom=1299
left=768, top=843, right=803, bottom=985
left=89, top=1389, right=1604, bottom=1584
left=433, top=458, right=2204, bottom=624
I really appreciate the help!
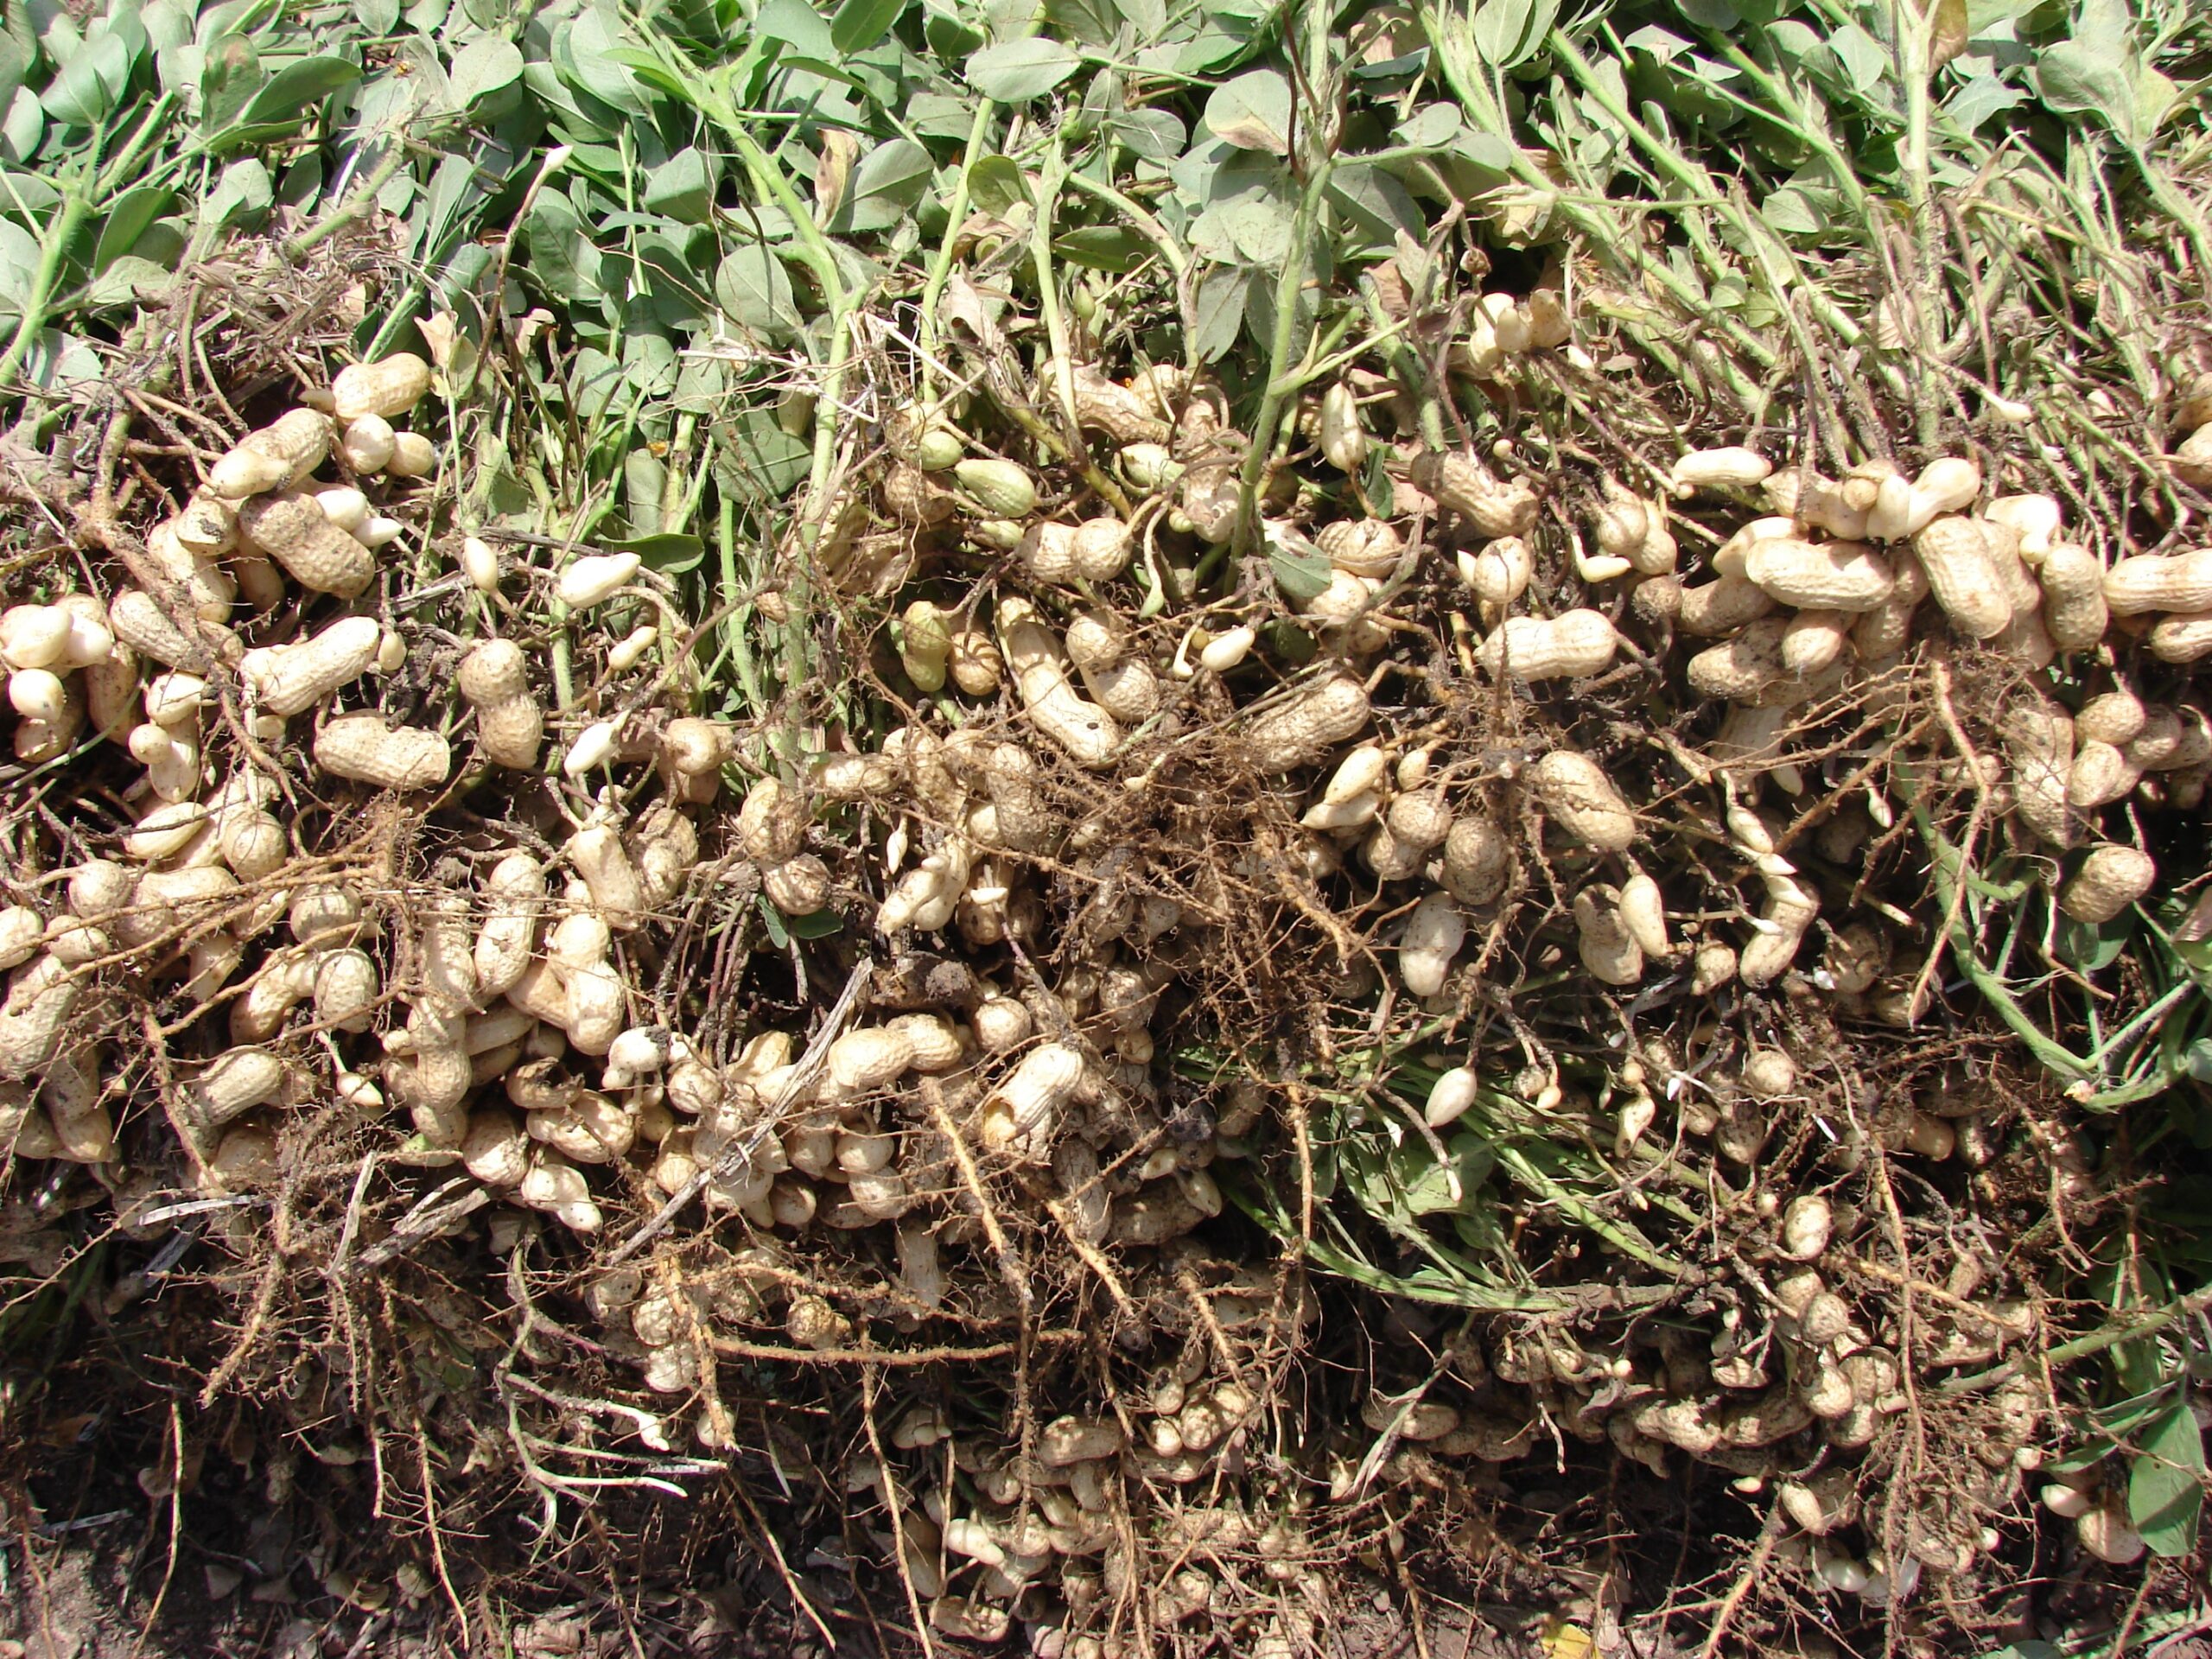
left=0, top=3, right=2212, bottom=1655
